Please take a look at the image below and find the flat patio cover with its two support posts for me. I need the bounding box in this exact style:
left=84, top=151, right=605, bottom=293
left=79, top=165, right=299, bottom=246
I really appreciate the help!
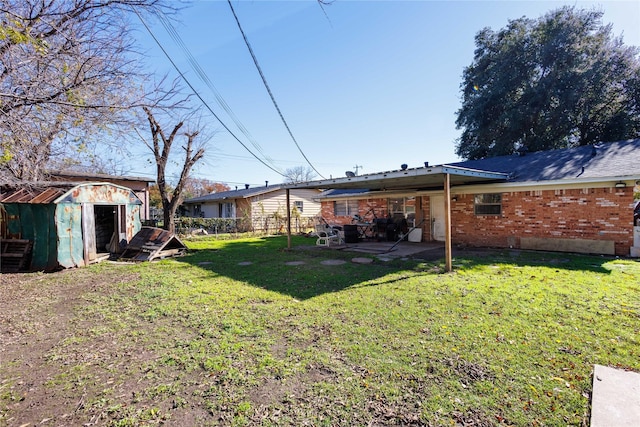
left=285, top=164, right=508, bottom=271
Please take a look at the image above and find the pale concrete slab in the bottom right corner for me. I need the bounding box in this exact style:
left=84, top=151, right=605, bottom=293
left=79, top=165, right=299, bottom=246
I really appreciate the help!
left=591, top=365, right=640, bottom=427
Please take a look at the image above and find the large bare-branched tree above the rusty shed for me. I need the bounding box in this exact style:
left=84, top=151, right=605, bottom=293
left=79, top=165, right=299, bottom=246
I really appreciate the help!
left=0, top=0, right=171, bottom=180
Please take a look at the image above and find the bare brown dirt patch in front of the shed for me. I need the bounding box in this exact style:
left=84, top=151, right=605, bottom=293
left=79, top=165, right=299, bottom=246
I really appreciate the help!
left=0, top=269, right=143, bottom=425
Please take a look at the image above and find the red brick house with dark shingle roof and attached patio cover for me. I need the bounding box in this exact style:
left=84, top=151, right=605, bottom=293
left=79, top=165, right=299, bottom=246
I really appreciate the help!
left=289, top=139, right=640, bottom=256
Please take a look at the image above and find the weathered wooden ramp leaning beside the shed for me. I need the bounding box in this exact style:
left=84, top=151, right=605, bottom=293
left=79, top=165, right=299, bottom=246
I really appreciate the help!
left=120, top=227, right=187, bottom=261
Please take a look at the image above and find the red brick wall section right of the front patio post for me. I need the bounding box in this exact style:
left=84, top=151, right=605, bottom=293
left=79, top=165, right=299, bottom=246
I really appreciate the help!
left=451, top=187, right=633, bottom=256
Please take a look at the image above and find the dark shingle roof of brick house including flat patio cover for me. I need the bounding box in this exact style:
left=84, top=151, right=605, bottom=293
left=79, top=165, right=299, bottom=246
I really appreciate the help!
left=287, top=139, right=640, bottom=197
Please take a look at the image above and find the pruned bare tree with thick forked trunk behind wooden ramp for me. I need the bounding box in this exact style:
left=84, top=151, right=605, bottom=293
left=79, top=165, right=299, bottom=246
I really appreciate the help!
left=143, top=107, right=204, bottom=233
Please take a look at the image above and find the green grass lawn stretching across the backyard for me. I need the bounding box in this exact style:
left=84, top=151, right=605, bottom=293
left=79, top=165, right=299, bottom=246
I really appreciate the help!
left=0, top=237, right=640, bottom=426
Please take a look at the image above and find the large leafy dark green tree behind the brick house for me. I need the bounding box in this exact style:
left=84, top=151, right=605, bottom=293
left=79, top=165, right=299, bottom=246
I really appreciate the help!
left=456, top=6, right=640, bottom=159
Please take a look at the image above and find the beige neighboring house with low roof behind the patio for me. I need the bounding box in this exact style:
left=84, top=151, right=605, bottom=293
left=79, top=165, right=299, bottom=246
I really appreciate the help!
left=182, top=185, right=320, bottom=231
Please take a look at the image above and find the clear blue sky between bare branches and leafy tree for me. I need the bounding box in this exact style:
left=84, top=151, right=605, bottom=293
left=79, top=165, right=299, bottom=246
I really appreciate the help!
left=131, top=0, right=640, bottom=188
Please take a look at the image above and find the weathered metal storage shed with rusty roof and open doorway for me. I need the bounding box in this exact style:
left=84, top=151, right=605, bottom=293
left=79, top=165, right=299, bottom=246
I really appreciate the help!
left=0, top=182, right=142, bottom=271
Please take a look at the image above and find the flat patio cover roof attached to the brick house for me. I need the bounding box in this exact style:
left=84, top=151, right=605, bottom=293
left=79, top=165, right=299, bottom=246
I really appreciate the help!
left=285, top=165, right=508, bottom=191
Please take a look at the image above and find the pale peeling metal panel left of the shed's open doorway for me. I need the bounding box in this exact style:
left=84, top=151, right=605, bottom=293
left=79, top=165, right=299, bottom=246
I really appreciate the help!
left=56, top=203, right=84, bottom=268
